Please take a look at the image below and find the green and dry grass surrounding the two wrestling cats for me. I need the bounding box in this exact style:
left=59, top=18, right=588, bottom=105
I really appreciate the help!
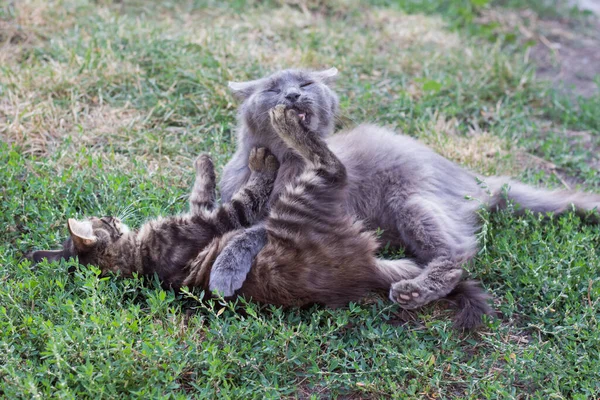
left=0, top=0, right=600, bottom=399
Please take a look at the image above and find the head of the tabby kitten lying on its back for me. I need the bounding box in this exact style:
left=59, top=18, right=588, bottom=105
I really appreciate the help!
left=29, top=217, right=135, bottom=276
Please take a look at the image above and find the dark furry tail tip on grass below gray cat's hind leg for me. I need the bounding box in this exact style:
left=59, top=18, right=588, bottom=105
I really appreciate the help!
left=446, top=280, right=496, bottom=331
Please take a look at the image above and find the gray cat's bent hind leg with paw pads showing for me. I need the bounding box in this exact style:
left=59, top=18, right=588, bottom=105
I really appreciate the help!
left=390, top=196, right=477, bottom=309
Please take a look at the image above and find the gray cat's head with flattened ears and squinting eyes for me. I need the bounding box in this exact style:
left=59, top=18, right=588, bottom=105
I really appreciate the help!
left=229, top=68, right=339, bottom=135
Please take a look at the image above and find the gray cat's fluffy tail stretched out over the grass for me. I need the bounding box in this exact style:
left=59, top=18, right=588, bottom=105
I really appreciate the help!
left=482, top=176, right=600, bottom=223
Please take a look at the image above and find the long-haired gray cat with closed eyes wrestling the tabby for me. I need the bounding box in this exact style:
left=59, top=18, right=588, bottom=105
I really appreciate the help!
left=211, top=68, right=600, bottom=325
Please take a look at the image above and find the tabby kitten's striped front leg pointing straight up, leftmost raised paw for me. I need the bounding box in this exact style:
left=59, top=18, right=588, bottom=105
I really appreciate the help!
left=189, top=154, right=216, bottom=215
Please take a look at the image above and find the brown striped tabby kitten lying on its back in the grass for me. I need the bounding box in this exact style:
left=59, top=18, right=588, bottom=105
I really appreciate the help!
left=33, top=106, right=460, bottom=316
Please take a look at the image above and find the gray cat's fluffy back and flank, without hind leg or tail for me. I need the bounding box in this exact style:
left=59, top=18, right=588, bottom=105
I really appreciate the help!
left=327, top=125, right=481, bottom=246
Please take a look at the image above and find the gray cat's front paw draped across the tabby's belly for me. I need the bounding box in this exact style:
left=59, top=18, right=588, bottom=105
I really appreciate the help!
left=209, top=224, right=267, bottom=297
